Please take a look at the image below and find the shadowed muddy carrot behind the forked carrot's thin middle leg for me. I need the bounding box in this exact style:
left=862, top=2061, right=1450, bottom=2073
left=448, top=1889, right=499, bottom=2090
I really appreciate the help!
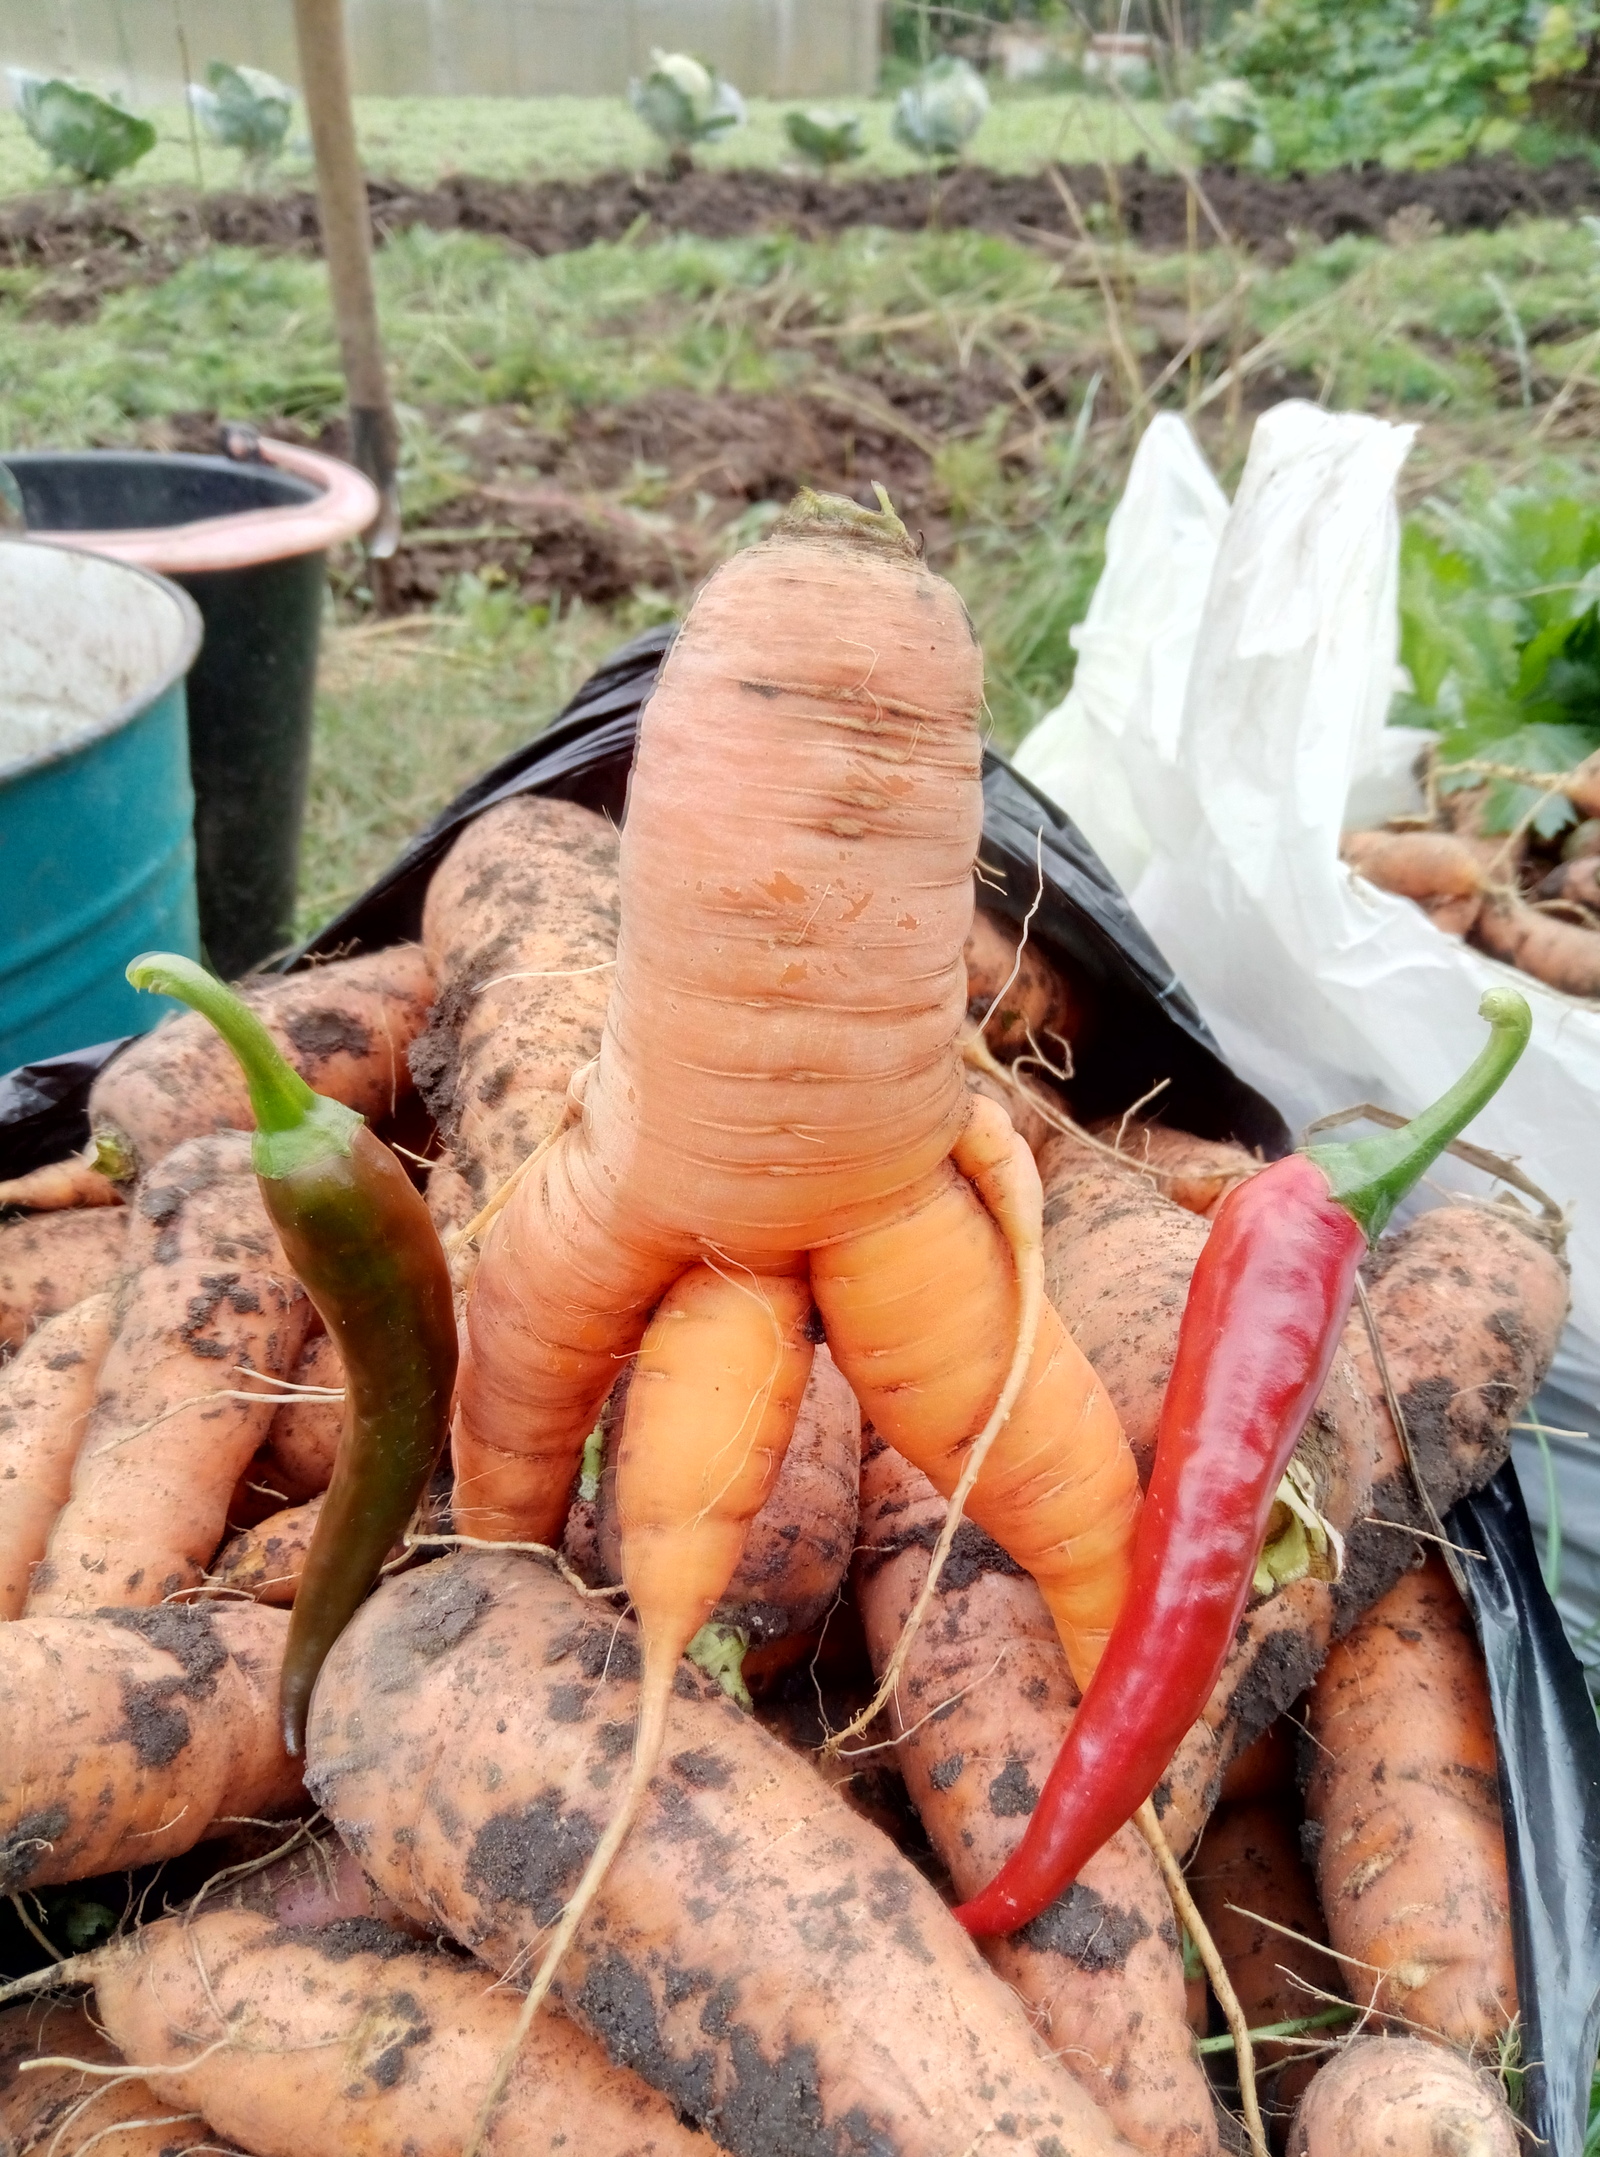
left=595, top=1348, right=860, bottom=1650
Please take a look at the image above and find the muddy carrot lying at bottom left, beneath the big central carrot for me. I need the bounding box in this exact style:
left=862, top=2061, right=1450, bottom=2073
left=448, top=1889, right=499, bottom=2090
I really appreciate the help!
left=95, top=1911, right=705, bottom=2157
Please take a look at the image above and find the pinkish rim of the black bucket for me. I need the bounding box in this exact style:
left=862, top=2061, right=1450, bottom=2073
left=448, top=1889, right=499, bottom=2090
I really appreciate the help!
left=17, top=436, right=377, bottom=576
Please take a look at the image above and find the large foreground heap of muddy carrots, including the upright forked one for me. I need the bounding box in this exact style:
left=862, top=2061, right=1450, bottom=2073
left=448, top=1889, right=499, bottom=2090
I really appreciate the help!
left=0, top=500, right=1568, bottom=2157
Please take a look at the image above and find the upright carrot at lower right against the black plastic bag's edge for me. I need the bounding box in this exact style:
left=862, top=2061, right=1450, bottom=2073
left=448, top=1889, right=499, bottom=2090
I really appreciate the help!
left=1305, top=1555, right=1516, bottom=2051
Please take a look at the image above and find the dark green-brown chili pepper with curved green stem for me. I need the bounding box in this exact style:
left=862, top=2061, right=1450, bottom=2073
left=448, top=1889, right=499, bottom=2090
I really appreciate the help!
left=127, top=951, right=457, bottom=1756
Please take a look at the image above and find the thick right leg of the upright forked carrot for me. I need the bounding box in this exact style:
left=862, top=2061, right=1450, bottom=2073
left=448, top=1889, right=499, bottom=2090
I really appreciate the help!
left=811, top=1163, right=1139, bottom=1685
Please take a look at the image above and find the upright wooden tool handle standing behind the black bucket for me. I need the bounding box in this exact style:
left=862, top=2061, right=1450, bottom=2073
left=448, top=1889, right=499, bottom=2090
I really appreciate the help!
left=295, top=0, right=399, bottom=561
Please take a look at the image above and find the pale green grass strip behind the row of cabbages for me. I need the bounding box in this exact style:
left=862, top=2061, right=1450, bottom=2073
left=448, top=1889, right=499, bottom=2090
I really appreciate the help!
left=0, top=91, right=1171, bottom=196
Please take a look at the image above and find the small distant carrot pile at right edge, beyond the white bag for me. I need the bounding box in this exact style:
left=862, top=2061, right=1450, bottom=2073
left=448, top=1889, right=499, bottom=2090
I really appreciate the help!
left=1341, top=757, right=1600, bottom=999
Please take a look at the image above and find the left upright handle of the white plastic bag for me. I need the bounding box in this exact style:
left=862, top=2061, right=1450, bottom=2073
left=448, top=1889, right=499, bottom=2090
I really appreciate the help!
left=1016, top=412, right=1227, bottom=891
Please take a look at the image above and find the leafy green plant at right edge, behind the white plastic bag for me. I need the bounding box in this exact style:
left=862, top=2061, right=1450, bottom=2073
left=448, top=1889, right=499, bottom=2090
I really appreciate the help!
left=1395, top=487, right=1600, bottom=839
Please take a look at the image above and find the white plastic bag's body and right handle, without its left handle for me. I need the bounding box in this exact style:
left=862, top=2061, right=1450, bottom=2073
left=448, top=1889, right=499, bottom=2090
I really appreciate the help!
left=1121, top=403, right=1600, bottom=1402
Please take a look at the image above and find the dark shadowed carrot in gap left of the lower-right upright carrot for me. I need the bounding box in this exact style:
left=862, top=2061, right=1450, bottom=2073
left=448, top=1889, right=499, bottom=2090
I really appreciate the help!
left=1188, top=1777, right=1333, bottom=2129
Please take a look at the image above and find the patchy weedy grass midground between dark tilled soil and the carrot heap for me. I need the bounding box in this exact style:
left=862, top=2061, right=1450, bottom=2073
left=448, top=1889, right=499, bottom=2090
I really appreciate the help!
left=0, top=187, right=1600, bottom=925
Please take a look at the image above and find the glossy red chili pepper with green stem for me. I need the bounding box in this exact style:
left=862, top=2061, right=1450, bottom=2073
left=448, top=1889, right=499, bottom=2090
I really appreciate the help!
left=955, top=988, right=1531, bottom=1937
